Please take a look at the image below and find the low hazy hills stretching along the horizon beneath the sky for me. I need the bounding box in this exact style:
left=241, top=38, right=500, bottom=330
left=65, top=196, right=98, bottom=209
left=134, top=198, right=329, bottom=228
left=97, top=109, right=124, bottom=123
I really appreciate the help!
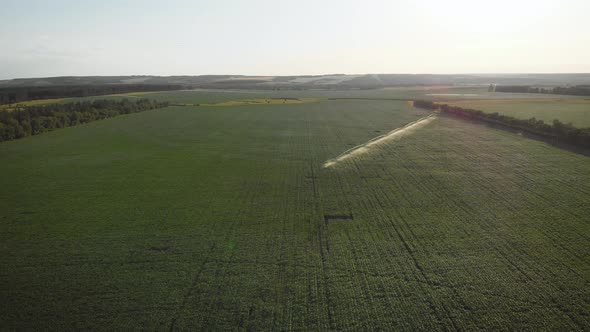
left=0, top=74, right=590, bottom=89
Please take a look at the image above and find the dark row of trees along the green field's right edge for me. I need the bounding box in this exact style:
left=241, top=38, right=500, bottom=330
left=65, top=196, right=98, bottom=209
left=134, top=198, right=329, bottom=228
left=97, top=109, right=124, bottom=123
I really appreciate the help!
left=414, top=100, right=590, bottom=148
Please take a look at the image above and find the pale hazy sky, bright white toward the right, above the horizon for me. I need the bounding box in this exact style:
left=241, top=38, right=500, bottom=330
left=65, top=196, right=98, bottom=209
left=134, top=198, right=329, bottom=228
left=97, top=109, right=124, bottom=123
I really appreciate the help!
left=0, top=0, right=590, bottom=79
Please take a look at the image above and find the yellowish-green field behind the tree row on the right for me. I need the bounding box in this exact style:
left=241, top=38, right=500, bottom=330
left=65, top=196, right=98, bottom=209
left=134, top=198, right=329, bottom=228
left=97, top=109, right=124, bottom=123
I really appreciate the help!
left=440, top=98, right=590, bottom=127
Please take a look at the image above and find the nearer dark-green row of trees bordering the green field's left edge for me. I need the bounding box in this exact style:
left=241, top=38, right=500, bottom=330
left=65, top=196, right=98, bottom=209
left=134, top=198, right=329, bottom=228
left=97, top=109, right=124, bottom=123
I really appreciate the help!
left=0, top=98, right=168, bottom=142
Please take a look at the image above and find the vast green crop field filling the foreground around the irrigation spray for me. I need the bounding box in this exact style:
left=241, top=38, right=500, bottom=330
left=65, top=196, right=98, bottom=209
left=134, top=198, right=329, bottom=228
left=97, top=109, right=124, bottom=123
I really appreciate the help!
left=0, top=90, right=590, bottom=331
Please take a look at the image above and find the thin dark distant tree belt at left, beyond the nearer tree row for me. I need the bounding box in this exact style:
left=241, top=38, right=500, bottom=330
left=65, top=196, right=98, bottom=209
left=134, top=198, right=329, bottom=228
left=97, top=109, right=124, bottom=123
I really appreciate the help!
left=0, top=84, right=185, bottom=104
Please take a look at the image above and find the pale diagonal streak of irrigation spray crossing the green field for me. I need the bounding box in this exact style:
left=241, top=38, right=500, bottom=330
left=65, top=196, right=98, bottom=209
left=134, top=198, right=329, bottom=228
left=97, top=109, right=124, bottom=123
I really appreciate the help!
left=324, top=113, right=436, bottom=168
